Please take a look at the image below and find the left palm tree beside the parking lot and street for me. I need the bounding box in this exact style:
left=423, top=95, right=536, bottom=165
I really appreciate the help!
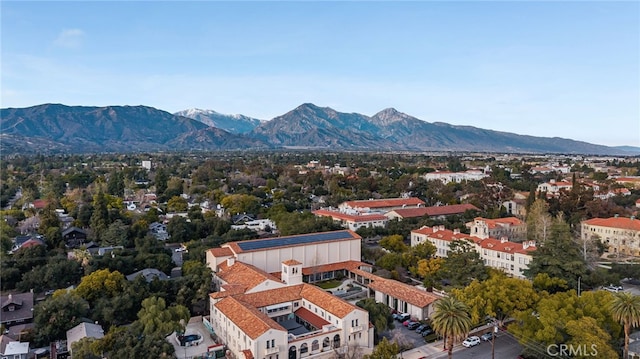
left=431, top=297, right=471, bottom=359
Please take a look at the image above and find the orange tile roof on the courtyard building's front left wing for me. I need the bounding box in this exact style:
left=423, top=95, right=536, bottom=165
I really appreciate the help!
left=214, top=297, right=287, bottom=340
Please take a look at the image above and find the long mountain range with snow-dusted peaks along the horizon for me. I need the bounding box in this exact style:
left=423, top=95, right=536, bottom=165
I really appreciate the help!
left=0, top=103, right=640, bottom=155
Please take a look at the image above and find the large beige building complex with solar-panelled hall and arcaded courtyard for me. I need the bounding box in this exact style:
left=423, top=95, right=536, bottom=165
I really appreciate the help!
left=204, top=230, right=439, bottom=359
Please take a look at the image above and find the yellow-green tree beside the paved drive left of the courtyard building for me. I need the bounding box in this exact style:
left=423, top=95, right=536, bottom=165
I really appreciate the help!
left=137, top=297, right=190, bottom=337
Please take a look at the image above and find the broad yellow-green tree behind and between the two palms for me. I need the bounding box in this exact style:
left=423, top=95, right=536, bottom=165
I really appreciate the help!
left=453, top=270, right=539, bottom=326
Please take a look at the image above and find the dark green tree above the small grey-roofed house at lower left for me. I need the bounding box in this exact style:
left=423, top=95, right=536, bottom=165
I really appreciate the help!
left=34, top=291, right=89, bottom=345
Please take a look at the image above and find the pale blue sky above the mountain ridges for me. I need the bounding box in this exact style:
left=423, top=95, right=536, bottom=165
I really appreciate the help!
left=0, top=0, right=640, bottom=146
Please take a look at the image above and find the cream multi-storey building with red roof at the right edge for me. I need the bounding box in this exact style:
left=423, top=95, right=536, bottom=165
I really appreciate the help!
left=582, top=216, right=640, bottom=257
